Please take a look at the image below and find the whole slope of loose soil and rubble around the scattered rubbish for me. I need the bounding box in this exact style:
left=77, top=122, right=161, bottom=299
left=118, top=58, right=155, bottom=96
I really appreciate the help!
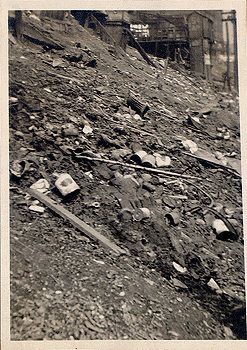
left=9, top=12, right=246, bottom=340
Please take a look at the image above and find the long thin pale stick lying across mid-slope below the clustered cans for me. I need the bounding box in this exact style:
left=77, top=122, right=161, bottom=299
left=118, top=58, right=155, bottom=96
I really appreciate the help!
left=76, top=155, right=202, bottom=180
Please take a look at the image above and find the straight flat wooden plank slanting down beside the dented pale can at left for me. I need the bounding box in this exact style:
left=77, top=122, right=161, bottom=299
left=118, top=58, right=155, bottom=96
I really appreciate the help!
left=27, top=188, right=127, bottom=255
